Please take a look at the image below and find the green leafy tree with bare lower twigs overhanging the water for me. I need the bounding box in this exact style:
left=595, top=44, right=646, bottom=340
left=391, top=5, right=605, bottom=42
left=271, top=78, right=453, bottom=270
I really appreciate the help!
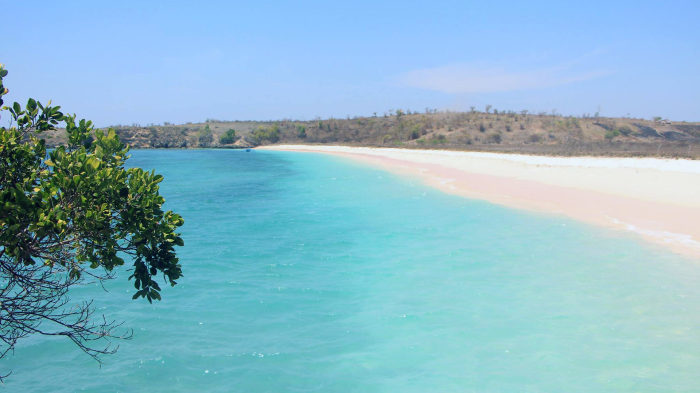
left=0, top=65, right=183, bottom=374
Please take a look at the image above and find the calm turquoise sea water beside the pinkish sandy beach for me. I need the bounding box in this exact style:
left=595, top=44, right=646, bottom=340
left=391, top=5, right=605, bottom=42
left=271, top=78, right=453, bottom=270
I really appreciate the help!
left=5, top=150, right=700, bottom=393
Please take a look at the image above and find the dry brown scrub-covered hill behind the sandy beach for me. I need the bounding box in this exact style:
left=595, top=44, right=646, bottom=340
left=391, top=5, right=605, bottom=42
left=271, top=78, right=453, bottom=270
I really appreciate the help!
left=41, top=107, right=700, bottom=158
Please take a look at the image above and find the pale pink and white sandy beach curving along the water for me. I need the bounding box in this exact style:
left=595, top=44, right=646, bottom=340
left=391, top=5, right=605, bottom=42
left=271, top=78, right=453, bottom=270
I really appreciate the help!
left=262, top=145, right=700, bottom=260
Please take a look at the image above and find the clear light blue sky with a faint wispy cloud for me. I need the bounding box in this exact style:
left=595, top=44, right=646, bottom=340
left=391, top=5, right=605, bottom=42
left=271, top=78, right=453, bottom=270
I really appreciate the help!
left=0, top=0, right=700, bottom=126
